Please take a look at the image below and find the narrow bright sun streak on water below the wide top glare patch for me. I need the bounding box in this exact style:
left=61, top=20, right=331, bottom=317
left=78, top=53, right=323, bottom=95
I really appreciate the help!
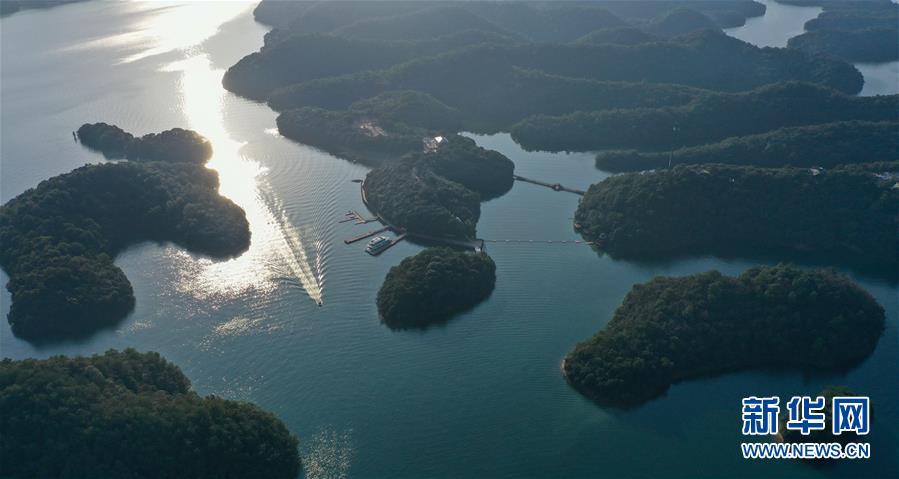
left=163, top=37, right=323, bottom=302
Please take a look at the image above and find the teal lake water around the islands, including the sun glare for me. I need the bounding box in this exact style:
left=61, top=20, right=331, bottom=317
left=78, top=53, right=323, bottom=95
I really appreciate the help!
left=0, top=2, right=899, bottom=478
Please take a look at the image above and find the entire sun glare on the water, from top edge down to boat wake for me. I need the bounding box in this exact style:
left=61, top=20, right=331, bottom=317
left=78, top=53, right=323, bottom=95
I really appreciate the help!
left=66, top=1, right=323, bottom=303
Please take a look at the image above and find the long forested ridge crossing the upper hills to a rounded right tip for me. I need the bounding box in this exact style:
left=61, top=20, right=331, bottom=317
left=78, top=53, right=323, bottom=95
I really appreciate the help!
left=268, top=30, right=863, bottom=115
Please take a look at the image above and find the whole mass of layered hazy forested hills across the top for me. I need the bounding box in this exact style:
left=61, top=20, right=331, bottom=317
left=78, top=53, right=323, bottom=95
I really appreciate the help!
left=223, top=1, right=880, bottom=164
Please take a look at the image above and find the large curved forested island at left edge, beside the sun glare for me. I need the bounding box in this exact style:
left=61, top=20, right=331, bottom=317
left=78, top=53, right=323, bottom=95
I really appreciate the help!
left=0, top=124, right=250, bottom=341
